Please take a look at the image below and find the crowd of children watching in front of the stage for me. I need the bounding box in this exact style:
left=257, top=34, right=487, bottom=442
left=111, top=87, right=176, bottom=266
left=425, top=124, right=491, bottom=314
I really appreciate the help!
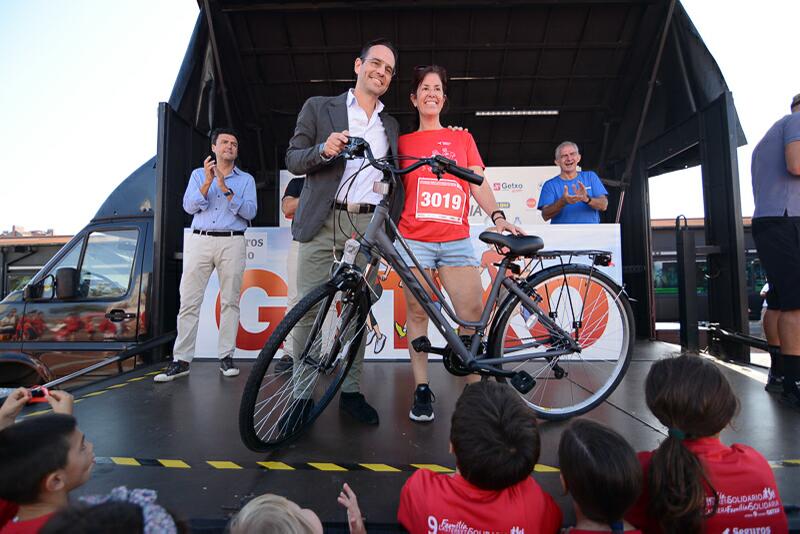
left=0, top=356, right=788, bottom=534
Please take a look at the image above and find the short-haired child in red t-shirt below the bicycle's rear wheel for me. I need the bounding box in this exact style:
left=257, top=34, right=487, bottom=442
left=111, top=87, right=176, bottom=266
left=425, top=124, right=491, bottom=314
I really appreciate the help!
left=397, top=381, right=561, bottom=534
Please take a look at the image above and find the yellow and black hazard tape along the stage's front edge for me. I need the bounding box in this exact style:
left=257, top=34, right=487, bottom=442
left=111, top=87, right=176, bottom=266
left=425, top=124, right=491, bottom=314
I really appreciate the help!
left=95, top=456, right=558, bottom=473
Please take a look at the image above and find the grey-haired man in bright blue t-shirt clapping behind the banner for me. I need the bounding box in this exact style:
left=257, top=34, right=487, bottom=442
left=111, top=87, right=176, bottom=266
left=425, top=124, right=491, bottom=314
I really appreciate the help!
left=538, top=141, right=608, bottom=224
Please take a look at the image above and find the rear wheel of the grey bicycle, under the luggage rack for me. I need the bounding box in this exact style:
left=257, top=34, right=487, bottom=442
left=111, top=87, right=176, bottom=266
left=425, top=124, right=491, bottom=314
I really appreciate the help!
left=490, top=264, right=634, bottom=420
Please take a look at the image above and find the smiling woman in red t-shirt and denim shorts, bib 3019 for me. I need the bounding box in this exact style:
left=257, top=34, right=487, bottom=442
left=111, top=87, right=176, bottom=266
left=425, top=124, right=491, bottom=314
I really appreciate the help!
left=398, top=65, right=521, bottom=421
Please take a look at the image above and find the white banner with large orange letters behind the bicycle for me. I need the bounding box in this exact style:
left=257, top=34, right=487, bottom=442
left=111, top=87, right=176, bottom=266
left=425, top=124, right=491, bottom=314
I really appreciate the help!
left=191, top=224, right=622, bottom=359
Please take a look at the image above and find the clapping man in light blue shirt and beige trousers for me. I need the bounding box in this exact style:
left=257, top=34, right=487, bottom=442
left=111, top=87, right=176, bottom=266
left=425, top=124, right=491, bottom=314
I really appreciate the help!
left=154, top=128, right=256, bottom=382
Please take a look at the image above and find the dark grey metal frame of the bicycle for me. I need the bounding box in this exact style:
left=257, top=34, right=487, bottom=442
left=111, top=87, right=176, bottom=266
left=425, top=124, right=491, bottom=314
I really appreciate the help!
left=334, top=167, right=581, bottom=376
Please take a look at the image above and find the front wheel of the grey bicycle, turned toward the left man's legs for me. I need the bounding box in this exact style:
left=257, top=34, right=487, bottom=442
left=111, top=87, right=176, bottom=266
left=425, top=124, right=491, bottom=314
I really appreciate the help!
left=239, top=283, right=369, bottom=452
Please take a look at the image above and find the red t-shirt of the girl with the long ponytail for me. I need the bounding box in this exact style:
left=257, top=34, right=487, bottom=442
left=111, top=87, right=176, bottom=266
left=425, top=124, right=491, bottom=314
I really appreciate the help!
left=626, top=438, right=789, bottom=534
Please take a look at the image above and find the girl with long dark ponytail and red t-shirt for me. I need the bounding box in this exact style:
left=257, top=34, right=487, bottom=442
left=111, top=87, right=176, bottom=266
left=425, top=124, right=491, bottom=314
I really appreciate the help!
left=627, top=356, right=788, bottom=534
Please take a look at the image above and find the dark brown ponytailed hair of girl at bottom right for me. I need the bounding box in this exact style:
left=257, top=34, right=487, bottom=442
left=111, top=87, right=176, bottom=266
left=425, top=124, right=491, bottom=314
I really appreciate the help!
left=645, top=356, right=739, bottom=533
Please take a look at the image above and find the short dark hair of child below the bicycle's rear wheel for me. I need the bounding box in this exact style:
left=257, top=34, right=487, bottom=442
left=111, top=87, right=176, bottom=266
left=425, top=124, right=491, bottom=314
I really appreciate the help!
left=450, top=380, right=539, bottom=490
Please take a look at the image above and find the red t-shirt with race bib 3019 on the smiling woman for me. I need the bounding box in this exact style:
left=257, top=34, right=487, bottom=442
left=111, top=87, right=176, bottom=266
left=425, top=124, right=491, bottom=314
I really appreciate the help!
left=398, top=128, right=483, bottom=243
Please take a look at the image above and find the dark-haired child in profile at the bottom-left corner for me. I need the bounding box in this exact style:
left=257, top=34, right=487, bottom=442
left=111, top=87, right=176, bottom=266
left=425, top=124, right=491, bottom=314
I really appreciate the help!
left=0, top=414, right=94, bottom=534
